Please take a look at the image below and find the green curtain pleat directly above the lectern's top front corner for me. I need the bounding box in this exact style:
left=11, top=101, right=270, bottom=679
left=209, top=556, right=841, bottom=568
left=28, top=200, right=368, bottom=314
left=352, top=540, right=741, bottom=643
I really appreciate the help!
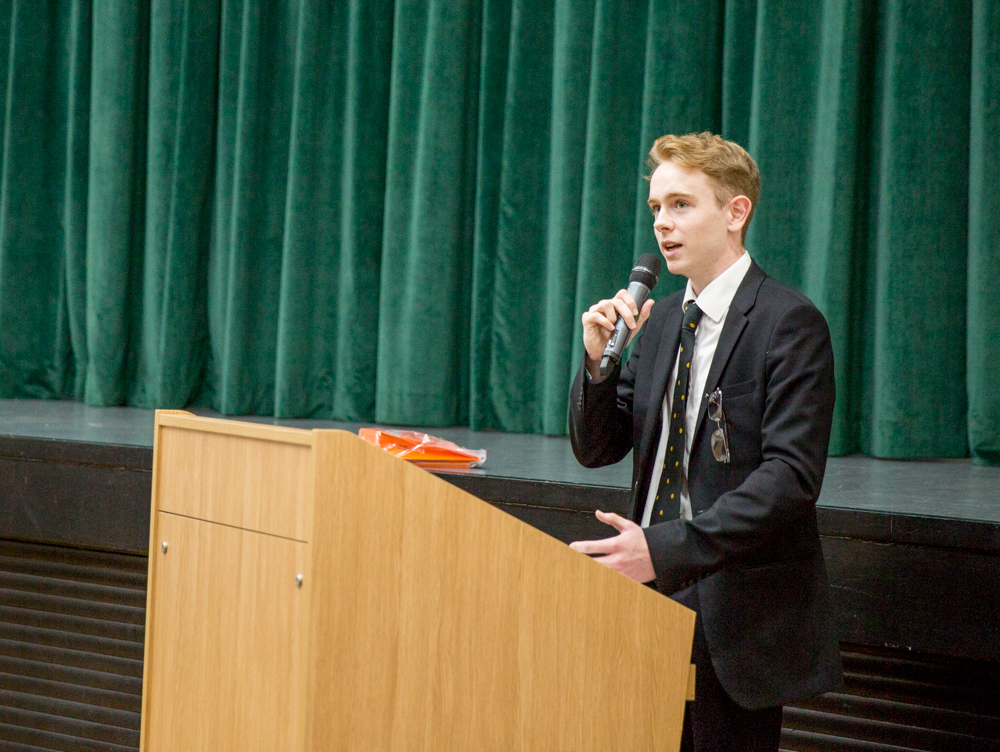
left=274, top=2, right=350, bottom=416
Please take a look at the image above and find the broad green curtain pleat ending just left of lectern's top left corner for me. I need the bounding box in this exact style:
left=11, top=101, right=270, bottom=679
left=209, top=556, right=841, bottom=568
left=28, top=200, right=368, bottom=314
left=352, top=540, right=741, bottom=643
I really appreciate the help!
left=83, top=0, right=149, bottom=405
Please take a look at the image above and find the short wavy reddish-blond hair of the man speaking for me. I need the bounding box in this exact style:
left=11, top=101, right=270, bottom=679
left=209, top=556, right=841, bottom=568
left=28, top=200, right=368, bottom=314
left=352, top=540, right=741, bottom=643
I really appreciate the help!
left=647, top=131, right=760, bottom=240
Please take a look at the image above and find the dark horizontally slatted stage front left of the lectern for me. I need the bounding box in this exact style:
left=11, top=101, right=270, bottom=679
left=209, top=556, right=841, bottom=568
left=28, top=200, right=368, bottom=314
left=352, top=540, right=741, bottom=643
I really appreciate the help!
left=0, top=540, right=146, bottom=752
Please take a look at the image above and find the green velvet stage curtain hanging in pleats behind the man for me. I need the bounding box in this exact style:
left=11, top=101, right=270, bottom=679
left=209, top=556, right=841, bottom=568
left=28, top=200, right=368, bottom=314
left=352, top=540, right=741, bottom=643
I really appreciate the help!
left=0, top=0, right=1000, bottom=464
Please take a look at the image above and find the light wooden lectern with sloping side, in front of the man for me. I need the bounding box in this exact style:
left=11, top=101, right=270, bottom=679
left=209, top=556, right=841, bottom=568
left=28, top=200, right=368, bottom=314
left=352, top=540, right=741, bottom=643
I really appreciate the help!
left=140, top=410, right=694, bottom=752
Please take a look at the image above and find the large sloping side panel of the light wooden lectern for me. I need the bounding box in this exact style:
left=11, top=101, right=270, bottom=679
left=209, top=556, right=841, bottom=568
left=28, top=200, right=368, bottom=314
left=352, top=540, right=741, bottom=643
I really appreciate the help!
left=307, top=431, right=694, bottom=752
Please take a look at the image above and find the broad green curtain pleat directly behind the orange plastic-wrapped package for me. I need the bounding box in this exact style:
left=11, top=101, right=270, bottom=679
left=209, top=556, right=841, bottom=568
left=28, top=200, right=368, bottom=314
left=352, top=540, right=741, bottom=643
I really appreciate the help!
left=375, top=0, right=480, bottom=425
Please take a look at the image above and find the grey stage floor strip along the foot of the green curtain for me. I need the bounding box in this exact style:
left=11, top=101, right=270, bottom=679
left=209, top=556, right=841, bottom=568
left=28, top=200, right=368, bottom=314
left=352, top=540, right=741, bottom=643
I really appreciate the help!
left=0, top=400, right=1000, bottom=525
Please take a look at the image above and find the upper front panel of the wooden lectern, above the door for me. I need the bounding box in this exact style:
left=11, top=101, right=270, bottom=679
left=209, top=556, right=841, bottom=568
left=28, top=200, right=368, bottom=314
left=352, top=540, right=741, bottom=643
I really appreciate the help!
left=156, top=424, right=313, bottom=540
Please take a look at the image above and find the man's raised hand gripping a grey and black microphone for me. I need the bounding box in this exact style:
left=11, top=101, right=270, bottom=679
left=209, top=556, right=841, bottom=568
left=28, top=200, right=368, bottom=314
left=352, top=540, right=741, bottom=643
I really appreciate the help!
left=583, top=253, right=660, bottom=379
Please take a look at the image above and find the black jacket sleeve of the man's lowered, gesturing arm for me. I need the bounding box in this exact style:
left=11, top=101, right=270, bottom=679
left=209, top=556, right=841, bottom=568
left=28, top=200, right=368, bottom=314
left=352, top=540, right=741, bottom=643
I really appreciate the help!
left=646, top=304, right=835, bottom=594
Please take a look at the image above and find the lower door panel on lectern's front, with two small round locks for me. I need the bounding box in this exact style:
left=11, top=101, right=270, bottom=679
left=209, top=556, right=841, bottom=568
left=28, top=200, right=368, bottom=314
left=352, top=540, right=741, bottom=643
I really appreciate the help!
left=143, top=512, right=308, bottom=752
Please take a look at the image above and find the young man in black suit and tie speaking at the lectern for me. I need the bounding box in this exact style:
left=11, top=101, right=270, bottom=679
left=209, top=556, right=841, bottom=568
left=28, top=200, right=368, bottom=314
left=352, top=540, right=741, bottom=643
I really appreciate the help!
left=570, top=133, right=841, bottom=752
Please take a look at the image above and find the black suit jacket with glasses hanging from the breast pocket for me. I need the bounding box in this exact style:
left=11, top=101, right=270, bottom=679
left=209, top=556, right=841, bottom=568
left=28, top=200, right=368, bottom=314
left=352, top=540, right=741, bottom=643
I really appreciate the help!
left=570, top=263, right=842, bottom=709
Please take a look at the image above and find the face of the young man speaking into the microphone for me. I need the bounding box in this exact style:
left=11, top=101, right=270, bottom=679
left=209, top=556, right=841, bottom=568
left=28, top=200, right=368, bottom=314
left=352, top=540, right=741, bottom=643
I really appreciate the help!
left=648, top=162, right=730, bottom=292
